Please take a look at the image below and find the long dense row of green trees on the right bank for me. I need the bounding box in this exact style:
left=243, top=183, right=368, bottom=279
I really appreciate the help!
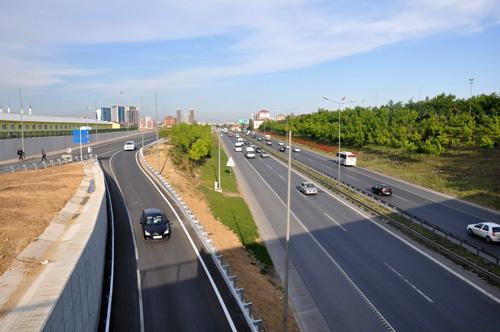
left=260, top=93, right=500, bottom=154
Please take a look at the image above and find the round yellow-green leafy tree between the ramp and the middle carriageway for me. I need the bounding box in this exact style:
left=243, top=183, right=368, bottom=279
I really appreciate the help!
left=160, top=123, right=212, bottom=164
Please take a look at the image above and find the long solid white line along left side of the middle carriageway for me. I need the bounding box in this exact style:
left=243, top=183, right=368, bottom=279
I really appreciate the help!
left=244, top=154, right=396, bottom=331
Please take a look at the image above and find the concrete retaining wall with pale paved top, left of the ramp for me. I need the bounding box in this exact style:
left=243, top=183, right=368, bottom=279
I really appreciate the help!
left=0, top=161, right=107, bottom=331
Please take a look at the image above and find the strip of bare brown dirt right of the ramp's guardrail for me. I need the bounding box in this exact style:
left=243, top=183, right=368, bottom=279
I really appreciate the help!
left=146, top=145, right=299, bottom=331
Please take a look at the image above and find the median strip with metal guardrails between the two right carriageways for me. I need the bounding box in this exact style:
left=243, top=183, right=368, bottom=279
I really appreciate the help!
left=245, top=135, right=500, bottom=282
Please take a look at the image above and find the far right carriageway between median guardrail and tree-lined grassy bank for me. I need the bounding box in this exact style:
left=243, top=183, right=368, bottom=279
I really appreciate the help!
left=252, top=136, right=500, bottom=256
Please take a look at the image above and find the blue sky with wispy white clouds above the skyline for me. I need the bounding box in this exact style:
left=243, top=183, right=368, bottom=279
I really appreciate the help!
left=0, top=0, right=500, bottom=122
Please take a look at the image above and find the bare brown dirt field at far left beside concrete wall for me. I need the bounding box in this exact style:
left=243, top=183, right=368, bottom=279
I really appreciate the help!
left=0, top=164, right=83, bottom=274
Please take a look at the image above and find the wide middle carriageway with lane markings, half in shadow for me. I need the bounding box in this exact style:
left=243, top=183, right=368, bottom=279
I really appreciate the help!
left=223, top=136, right=500, bottom=331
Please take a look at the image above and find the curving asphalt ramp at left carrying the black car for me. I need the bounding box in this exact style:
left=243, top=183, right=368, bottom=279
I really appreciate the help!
left=101, top=137, right=248, bottom=331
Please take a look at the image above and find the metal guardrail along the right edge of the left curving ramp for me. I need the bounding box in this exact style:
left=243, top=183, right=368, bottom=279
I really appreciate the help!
left=139, top=148, right=263, bottom=332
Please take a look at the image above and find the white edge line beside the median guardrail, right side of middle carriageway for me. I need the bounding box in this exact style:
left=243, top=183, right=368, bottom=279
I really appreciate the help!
left=273, top=148, right=500, bottom=304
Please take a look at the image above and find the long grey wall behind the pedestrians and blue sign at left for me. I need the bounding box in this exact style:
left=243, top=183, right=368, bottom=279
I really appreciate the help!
left=0, top=130, right=138, bottom=160
